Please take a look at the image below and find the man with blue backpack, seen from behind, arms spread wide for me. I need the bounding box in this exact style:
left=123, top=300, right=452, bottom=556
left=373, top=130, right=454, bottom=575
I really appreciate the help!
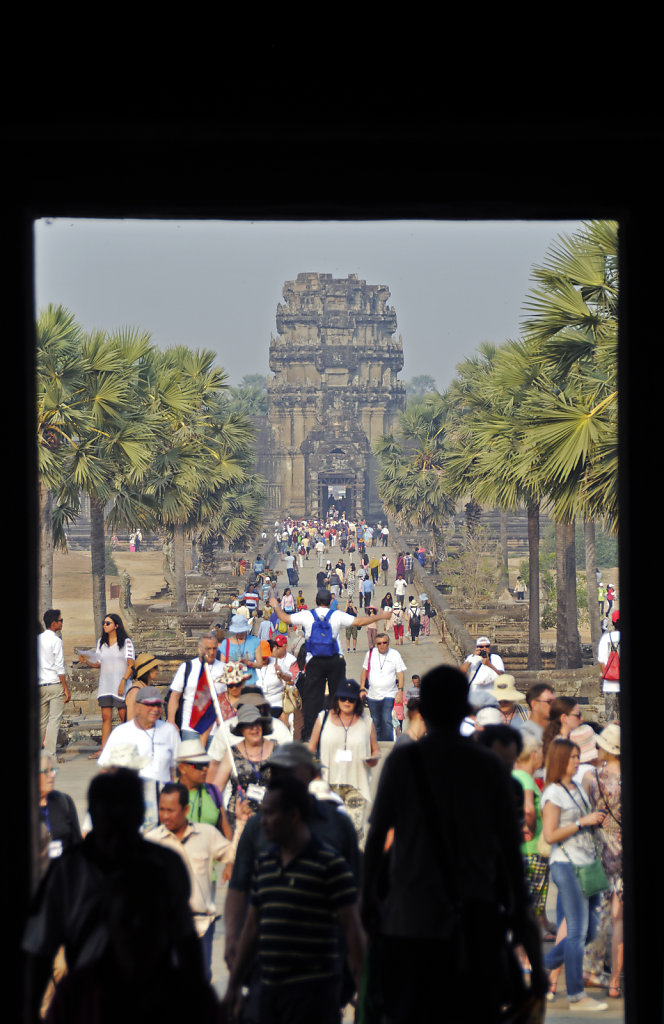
left=269, top=590, right=391, bottom=742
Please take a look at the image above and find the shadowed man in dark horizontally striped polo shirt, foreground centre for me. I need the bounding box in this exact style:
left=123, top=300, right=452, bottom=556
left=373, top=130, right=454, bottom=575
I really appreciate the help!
left=225, top=775, right=364, bottom=1024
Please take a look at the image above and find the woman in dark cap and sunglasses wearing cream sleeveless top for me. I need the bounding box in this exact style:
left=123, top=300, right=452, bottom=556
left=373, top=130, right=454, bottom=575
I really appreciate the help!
left=307, top=679, right=380, bottom=849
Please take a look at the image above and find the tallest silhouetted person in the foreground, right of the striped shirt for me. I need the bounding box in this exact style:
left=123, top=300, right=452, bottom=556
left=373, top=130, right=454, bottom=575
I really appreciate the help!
left=363, top=666, right=546, bottom=1024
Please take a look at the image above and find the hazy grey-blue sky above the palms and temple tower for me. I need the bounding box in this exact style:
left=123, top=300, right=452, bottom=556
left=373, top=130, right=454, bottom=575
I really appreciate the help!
left=35, top=218, right=580, bottom=388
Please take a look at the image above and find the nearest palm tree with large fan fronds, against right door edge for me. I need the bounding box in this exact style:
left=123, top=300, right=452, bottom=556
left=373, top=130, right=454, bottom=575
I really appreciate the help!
left=524, top=221, right=618, bottom=665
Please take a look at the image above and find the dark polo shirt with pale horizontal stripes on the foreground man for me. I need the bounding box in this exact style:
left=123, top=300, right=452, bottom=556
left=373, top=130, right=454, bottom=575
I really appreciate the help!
left=251, top=836, right=358, bottom=985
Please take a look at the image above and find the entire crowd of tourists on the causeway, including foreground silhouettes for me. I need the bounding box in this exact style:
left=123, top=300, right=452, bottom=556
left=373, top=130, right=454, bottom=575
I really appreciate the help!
left=29, top=515, right=623, bottom=1022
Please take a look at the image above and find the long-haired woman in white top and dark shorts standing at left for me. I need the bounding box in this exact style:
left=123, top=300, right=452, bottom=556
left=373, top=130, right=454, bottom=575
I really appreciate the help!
left=80, top=612, right=135, bottom=760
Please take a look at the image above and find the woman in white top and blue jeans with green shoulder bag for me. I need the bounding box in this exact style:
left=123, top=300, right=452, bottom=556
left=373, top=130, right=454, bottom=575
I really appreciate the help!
left=540, top=739, right=608, bottom=1013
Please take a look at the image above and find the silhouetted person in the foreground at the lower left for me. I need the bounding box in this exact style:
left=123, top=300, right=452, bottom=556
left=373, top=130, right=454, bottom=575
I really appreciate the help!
left=24, top=768, right=215, bottom=1024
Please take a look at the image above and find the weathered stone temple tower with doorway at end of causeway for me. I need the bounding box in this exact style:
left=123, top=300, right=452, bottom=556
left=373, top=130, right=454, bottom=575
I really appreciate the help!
left=258, top=273, right=406, bottom=519
